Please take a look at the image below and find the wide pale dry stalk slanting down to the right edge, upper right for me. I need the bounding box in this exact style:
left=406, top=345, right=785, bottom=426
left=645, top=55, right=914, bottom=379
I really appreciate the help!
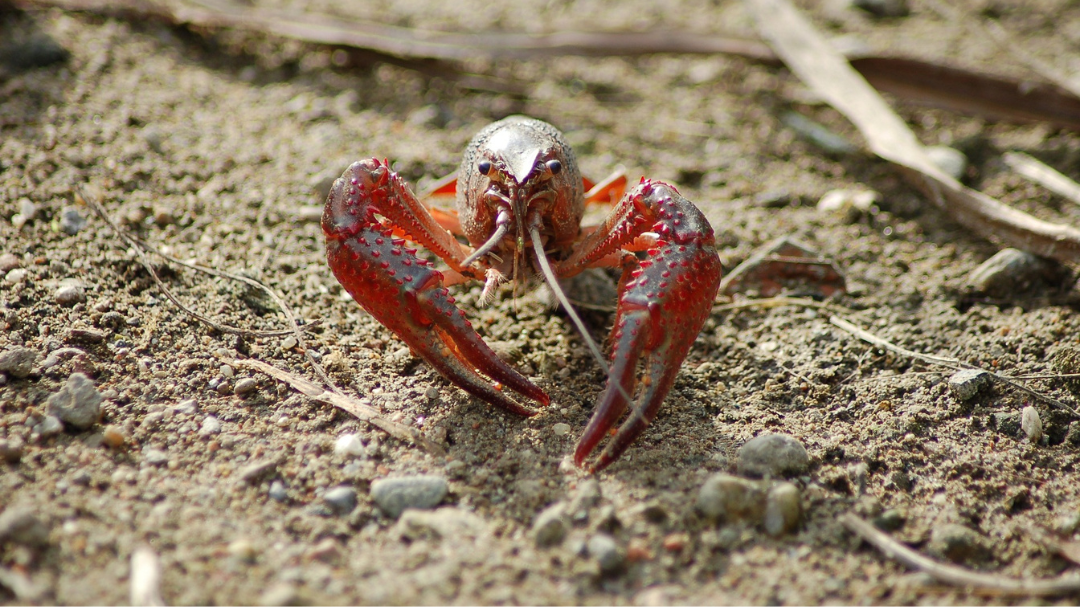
left=746, top=0, right=1080, bottom=261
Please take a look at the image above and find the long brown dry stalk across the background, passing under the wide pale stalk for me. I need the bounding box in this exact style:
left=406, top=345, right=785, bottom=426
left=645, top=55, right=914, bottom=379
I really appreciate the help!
left=15, top=0, right=1080, bottom=130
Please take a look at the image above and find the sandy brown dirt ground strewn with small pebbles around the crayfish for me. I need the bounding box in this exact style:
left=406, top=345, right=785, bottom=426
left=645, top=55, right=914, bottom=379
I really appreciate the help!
left=0, top=0, right=1080, bottom=604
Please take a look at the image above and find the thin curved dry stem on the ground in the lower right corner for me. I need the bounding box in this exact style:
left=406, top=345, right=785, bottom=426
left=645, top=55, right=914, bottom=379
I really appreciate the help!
left=840, top=512, right=1080, bottom=596
